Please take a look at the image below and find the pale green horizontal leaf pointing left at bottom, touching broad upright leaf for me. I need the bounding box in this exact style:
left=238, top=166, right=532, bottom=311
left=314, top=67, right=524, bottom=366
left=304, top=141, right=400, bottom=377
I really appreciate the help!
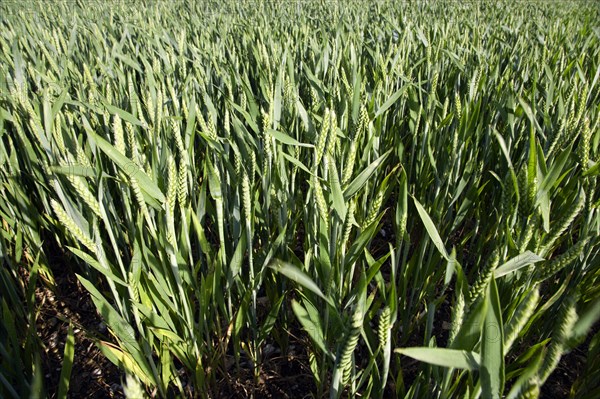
left=394, top=347, right=481, bottom=371
